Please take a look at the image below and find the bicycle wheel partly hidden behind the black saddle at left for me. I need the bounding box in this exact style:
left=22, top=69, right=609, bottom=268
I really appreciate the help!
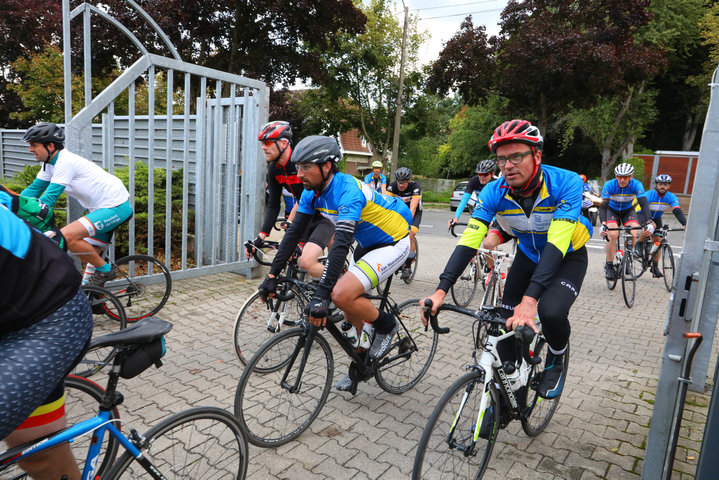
left=72, top=285, right=127, bottom=377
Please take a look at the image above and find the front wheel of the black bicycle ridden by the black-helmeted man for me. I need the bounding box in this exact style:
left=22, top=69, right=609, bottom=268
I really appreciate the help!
left=234, top=328, right=334, bottom=447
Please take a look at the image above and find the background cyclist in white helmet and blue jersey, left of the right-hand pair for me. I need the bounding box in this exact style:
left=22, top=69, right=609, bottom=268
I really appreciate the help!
left=599, top=163, right=654, bottom=280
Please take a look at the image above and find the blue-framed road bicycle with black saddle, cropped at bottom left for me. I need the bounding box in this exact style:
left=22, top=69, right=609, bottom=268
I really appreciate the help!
left=0, top=318, right=248, bottom=480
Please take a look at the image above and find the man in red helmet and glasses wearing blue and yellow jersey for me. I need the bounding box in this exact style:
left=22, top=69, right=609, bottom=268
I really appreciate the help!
left=421, top=120, right=592, bottom=398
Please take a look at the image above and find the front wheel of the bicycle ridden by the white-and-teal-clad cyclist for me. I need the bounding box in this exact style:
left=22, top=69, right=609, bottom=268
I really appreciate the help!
left=105, top=255, right=172, bottom=322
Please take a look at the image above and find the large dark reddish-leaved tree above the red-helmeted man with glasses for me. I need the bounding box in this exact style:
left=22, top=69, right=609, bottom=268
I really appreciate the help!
left=497, top=0, right=661, bottom=135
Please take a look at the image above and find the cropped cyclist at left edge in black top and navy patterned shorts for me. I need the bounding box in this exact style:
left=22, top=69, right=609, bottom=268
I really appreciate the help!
left=0, top=203, right=92, bottom=480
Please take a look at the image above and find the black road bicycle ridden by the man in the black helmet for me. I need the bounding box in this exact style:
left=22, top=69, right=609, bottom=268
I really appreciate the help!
left=234, top=277, right=444, bottom=447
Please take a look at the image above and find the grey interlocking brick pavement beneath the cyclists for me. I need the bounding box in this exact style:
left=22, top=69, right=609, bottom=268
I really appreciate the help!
left=94, top=212, right=716, bottom=480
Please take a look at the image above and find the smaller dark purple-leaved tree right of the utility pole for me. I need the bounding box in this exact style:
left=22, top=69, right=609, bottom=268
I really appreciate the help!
left=427, top=15, right=496, bottom=105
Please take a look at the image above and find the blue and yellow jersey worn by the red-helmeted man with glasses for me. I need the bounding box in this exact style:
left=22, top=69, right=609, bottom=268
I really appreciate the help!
left=458, top=165, right=592, bottom=263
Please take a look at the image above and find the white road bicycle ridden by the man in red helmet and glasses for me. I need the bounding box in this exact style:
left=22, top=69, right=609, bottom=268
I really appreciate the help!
left=412, top=299, right=569, bottom=480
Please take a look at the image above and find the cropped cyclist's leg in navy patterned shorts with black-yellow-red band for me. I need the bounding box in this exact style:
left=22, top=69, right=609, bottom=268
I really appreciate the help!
left=0, top=291, right=92, bottom=479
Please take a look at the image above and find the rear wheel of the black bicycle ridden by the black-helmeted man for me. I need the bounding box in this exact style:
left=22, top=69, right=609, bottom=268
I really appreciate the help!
left=374, top=298, right=438, bottom=393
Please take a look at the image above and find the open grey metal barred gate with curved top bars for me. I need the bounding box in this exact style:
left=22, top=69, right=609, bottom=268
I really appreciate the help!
left=63, top=0, right=269, bottom=278
